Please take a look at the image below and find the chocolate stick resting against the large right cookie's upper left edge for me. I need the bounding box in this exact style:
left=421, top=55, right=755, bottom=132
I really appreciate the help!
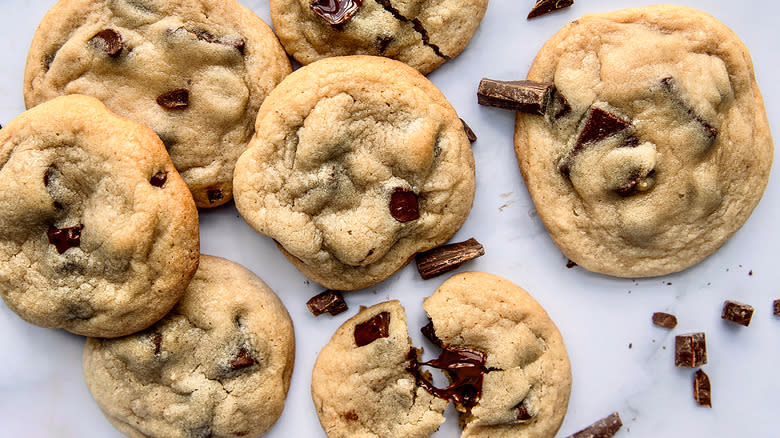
left=477, top=78, right=555, bottom=116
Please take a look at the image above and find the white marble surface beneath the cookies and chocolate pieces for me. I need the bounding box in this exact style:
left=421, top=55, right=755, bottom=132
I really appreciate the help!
left=0, top=0, right=780, bottom=438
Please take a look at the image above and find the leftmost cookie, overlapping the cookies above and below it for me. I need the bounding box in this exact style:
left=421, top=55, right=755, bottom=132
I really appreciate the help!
left=0, top=95, right=199, bottom=337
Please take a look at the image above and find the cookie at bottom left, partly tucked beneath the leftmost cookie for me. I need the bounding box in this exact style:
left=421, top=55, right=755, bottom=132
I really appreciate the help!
left=83, top=256, right=295, bottom=438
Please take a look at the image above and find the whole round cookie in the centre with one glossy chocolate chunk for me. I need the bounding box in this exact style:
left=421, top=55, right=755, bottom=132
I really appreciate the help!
left=233, top=56, right=474, bottom=290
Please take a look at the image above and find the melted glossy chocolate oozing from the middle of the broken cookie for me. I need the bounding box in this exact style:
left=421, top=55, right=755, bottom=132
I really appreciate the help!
left=406, top=345, right=488, bottom=410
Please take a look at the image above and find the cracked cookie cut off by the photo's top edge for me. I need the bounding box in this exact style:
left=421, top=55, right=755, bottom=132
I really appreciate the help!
left=270, top=0, right=488, bottom=74
